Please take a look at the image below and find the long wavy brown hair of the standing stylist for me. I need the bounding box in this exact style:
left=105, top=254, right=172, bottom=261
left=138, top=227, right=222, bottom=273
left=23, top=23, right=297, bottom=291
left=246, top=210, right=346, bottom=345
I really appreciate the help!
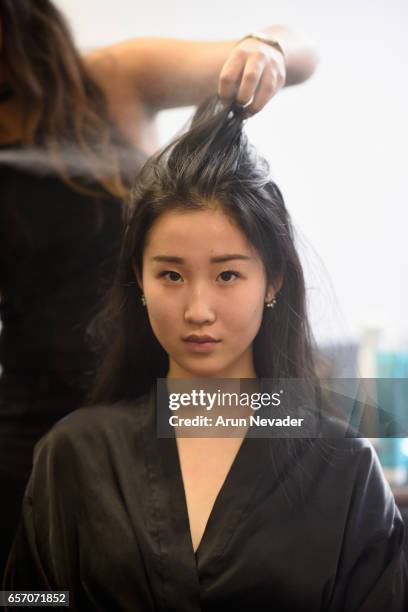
left=0, top=0, right=129, bottom=197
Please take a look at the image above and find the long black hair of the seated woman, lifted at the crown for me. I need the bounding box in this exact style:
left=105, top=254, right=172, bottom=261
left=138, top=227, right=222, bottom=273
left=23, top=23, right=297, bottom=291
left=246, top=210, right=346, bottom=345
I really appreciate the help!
left=90, top=98, right=314, bottom=403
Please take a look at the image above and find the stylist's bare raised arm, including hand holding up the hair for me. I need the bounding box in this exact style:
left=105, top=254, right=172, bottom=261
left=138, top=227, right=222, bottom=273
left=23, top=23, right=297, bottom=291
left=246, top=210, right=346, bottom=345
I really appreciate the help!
left=85, top=26, right=317, bottom=152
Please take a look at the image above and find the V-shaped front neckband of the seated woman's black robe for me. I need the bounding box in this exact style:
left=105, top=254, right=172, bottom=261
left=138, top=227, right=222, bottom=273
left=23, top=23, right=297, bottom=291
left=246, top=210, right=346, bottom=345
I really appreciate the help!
left=139, top=390, right=286, bottom=612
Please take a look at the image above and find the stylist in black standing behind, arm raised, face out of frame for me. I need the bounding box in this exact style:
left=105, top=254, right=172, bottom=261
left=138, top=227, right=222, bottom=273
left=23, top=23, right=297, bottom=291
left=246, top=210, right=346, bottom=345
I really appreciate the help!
left=0, top=0, right=315, bottom=572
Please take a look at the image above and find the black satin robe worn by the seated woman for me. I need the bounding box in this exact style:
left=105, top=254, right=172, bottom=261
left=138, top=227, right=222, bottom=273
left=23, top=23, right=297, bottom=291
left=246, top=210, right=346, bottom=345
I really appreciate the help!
left=3, top=395, right=408, bottom=612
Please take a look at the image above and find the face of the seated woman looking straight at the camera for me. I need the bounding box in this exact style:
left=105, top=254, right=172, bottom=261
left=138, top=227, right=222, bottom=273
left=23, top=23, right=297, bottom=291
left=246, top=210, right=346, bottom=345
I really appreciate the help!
left=141, top=208, right=275, bottom=378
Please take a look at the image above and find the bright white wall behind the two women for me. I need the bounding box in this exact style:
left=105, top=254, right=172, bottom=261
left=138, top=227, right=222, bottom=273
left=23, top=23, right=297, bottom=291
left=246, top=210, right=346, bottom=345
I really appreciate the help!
left=58, top=0, right=408, bottom=346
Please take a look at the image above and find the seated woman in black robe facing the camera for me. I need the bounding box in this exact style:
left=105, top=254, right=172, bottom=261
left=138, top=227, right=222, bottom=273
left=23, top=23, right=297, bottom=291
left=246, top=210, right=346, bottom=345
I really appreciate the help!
left=4, top=101, right=408, bottom=612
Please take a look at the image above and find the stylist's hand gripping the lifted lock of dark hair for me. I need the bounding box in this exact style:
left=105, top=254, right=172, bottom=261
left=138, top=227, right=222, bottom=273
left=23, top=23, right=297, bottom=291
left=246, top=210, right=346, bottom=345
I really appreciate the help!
left=218, top=38, right=286, bottom=114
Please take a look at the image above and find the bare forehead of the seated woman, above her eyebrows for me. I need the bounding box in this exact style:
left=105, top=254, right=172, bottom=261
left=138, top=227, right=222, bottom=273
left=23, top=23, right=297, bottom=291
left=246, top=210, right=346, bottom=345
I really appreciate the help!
left=146, top=208, right=255, bottom=256
